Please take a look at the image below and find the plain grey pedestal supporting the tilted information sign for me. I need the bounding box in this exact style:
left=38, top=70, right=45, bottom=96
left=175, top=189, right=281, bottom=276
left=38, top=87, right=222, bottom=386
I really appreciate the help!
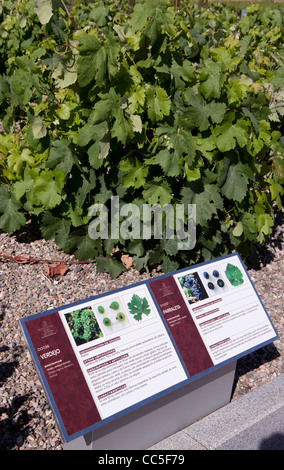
left=63, top=361, right=236, bottom=450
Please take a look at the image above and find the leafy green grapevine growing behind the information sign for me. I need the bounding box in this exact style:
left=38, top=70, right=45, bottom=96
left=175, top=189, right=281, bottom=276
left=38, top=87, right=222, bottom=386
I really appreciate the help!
left=0, top=0, right=284, bottom=277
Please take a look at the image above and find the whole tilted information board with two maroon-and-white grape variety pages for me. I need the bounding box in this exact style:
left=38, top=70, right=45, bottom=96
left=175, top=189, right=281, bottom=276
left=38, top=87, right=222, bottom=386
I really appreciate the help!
left=20, top=254, right=278, bottom=442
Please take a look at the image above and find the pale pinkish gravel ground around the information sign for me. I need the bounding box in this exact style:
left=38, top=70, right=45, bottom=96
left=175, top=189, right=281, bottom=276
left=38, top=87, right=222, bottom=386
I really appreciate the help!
left=0, top=211, right=284, bottom=450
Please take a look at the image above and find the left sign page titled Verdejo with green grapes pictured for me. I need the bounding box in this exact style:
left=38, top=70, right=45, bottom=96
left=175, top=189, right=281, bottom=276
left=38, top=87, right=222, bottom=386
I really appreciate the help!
left=21, top=284, right=188, bottom=441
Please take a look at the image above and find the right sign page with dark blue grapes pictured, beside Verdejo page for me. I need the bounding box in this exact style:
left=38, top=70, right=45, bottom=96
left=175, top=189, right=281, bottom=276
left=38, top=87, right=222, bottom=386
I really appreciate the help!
left=149, top=254, right=277, bottom=376
